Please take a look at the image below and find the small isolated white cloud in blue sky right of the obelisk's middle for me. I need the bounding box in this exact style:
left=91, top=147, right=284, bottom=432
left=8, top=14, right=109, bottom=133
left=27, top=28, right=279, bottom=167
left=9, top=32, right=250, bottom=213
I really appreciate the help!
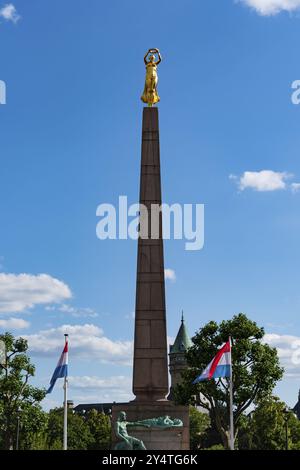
left=229, top=170, right=292, bottom=191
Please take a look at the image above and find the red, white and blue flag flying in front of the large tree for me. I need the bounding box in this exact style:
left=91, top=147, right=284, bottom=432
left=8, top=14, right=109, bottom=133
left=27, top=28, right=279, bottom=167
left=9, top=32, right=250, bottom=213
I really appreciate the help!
left=193, top=341, right=231, bottom=384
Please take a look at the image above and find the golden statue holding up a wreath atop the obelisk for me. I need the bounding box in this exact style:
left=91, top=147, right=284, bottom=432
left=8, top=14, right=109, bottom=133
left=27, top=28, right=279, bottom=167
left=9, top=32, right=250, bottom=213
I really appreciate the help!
left=141, top=49, right=161, bottom=106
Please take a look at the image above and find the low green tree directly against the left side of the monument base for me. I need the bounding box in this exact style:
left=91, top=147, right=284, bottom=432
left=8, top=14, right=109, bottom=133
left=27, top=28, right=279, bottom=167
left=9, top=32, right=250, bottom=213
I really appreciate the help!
left=84, top=410, right=111, bottom=450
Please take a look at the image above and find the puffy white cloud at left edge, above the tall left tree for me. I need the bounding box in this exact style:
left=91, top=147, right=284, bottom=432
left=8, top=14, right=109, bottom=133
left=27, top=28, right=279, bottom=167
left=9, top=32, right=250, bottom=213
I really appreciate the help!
left=0, top=273, right=72, bottom=313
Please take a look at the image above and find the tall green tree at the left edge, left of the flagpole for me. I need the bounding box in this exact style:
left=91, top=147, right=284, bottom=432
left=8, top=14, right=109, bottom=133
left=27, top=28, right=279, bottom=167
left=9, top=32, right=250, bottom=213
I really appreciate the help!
left=0, top=333, right=46, bottom=449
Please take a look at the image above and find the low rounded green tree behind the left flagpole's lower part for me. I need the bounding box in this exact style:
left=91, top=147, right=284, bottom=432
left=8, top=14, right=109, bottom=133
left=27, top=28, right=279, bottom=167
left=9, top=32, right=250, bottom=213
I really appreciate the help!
left=46, top=408, right=94, bottom=450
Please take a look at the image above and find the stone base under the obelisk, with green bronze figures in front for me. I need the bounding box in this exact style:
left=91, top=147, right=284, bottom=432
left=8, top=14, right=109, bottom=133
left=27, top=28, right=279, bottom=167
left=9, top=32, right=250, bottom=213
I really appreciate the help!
left=112, top=400, right=190, bottom=450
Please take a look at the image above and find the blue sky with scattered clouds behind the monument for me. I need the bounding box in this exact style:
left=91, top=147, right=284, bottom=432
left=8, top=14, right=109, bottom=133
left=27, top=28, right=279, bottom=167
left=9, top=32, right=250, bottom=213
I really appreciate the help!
left=0, top=0, right=300, bottom=407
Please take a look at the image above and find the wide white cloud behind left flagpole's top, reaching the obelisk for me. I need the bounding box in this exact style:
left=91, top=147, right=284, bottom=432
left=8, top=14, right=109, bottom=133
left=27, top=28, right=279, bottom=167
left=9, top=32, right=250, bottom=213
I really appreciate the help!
left=24, top=324, right=133, bottom=365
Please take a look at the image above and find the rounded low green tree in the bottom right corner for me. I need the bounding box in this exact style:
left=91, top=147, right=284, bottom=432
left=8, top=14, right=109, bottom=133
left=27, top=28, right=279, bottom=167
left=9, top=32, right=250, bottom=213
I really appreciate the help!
left=239, top=396, right=300, bottom=450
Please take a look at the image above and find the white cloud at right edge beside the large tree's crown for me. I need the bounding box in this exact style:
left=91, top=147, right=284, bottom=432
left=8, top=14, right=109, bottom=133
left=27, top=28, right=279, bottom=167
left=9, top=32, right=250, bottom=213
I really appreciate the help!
left=264, top=333, right=300, bottom=378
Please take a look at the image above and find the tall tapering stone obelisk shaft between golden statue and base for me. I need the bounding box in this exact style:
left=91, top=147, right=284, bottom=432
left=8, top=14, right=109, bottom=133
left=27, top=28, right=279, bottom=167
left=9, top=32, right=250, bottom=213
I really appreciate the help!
left=133, top=107, right=168, bottom=402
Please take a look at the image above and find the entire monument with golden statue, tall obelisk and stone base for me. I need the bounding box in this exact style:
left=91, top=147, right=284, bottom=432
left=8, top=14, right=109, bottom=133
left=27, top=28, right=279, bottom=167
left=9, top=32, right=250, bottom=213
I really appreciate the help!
left=112, top=49, right=189, bottom=450
